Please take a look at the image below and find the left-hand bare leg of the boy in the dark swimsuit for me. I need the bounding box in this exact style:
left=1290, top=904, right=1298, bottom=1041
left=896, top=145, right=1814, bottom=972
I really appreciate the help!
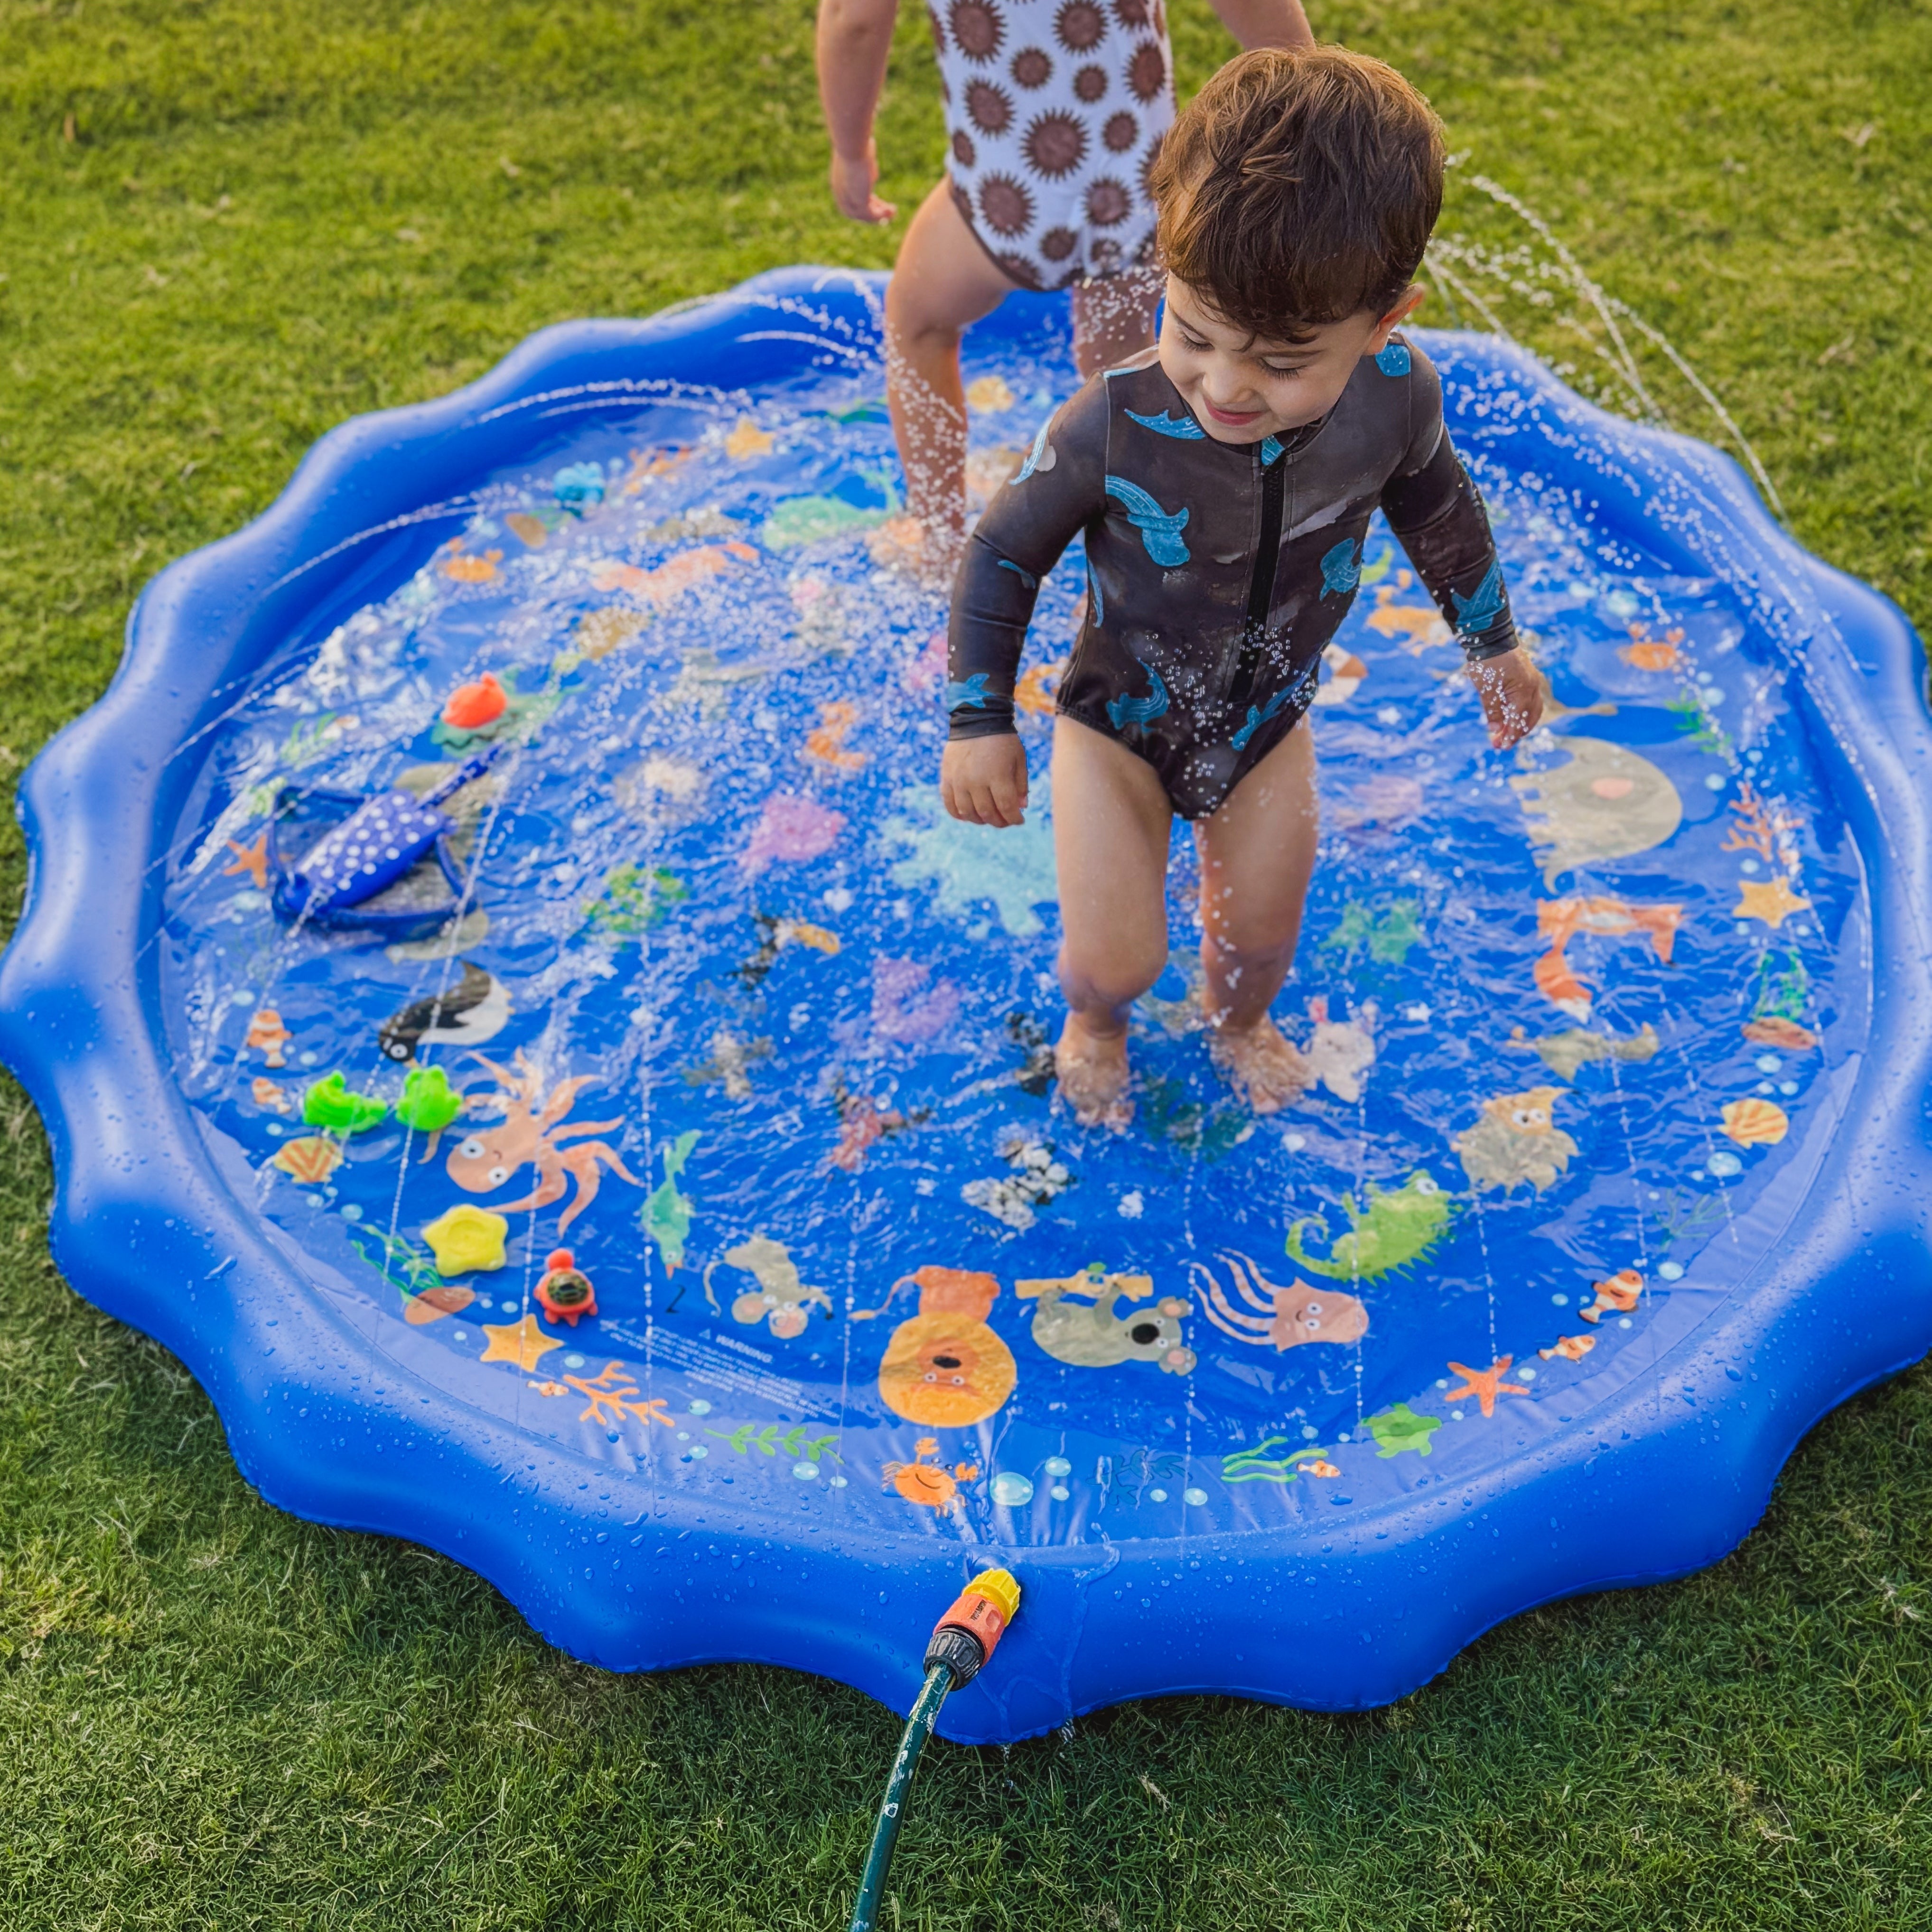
left=1053, top=717, right=1173, bottom=1128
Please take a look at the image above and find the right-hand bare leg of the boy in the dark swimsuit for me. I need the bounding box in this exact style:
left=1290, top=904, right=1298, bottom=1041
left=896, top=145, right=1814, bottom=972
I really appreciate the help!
left=1198, top=719, right=1319, bottom=1113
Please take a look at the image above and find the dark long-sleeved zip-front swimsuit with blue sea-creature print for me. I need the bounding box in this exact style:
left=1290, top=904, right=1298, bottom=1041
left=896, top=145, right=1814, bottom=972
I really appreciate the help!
left=947, top=336, right=1517, bottom=819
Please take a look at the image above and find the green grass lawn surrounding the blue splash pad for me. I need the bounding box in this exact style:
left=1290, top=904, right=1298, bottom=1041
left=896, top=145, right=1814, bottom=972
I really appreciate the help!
left=0, top=0, right=1932, bottom=1932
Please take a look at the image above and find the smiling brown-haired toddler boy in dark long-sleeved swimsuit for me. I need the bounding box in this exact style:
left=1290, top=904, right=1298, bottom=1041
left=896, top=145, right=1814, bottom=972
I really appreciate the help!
left=941, top=47, right=1542, bottom=1126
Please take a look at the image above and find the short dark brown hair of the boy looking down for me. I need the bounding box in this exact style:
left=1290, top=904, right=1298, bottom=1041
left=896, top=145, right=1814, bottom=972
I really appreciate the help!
left=1148, top=47, right=1443, bottom=342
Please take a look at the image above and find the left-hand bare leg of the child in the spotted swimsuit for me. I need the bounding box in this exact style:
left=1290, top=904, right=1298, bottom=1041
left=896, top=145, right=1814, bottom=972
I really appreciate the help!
left=885, top=178, right=1014, bottom=583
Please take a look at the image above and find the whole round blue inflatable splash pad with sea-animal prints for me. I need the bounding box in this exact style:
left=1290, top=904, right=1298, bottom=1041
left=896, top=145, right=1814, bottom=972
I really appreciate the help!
left=0, top=271, right=1932, bottom=1741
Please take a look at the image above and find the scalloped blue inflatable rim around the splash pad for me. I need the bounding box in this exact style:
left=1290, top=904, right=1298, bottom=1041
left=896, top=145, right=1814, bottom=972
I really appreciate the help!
left=0, top=269, right=1932, bottom=1743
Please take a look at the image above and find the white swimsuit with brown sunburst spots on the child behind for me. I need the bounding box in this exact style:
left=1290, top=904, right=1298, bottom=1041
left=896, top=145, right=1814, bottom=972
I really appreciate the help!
left=931, top=0, right=1175, bottom=288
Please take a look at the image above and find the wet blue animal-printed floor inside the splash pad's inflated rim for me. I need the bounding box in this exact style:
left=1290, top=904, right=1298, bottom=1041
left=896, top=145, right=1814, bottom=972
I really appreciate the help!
left=159, top=320, right=1870, bottom=1548
